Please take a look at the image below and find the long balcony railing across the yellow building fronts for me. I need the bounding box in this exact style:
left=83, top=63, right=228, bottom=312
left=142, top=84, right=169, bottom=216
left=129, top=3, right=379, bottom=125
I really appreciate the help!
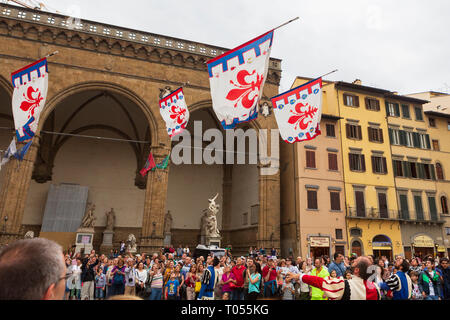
left=346, top=207, right=445, bottom=223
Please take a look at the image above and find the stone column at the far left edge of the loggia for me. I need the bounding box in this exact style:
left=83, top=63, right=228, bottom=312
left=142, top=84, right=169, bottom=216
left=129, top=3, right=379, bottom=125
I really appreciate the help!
left=0, top=136, right=39, bottom=244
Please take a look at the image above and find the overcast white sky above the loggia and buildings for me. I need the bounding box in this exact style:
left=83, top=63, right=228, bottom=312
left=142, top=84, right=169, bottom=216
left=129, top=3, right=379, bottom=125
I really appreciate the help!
left=10, top=0, right=450, bottom=94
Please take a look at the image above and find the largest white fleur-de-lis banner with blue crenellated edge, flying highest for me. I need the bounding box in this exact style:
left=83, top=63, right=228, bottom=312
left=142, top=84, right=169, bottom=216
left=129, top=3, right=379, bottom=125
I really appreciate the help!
left=207, top=30, right=273, bottom=129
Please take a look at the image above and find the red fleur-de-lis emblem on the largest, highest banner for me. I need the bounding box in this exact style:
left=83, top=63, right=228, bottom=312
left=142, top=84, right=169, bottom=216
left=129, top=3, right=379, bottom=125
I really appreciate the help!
left=226, top=70, right=264, bottom=109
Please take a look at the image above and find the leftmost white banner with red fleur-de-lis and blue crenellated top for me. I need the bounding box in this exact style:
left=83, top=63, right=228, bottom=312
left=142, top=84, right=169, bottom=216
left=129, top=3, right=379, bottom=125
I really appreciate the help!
left=11, top=58, right=48, bottom=142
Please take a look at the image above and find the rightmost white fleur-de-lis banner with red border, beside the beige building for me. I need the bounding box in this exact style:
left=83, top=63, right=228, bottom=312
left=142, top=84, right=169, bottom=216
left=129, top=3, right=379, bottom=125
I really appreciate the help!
left=271, top=78, right=322, bottom=143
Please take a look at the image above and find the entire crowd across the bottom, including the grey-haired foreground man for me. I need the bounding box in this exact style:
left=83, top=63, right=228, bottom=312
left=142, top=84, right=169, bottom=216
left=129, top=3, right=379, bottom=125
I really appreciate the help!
left=0, top=238, right=450, bottom=300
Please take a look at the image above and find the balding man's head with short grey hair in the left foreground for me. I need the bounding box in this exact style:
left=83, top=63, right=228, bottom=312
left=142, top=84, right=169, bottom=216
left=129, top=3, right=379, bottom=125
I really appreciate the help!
left=0, top=238, right=66, bottom=300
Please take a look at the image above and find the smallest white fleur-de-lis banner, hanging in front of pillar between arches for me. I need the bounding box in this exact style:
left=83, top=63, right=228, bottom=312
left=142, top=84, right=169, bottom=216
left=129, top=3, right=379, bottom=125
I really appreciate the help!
left=159, top=88, right=189, bottom=138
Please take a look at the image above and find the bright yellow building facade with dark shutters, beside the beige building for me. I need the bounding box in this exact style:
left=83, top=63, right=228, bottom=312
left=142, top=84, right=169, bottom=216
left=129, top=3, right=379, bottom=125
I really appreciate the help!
left=334, top=81, right=404, bottom=259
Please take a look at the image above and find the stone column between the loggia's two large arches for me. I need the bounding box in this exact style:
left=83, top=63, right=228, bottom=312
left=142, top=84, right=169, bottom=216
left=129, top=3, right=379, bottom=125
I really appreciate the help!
left=140, top=147, right=169, bottom=252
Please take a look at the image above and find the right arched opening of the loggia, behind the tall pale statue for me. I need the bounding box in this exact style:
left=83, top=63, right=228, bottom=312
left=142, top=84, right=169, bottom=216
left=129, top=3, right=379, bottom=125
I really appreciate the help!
left=165, top=104, right=259, bottom=253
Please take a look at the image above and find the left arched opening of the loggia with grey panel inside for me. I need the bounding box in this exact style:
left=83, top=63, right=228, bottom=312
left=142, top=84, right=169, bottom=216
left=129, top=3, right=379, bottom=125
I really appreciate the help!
left=22, top=85, right=153, bottom=249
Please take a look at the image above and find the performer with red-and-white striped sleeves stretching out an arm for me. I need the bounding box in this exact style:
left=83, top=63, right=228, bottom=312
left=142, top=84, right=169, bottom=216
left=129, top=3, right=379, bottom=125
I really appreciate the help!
left=286, top=257, right=381, bottom=300
